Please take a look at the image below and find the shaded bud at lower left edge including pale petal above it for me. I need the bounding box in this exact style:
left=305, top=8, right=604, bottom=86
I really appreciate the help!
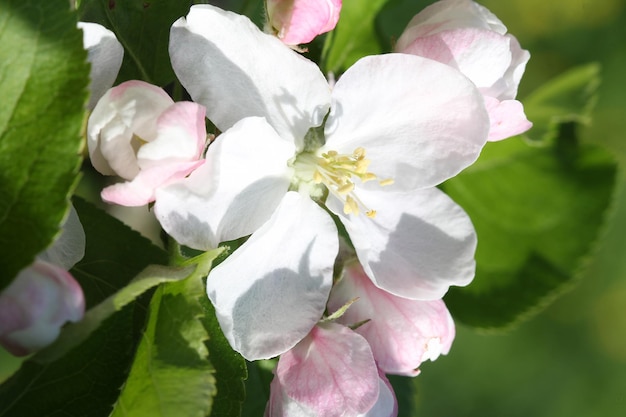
left=0, top=208, right=85, bottom=356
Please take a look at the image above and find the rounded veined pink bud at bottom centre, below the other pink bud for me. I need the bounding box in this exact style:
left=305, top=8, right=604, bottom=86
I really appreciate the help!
left=275, top=323, right=380, bottom=417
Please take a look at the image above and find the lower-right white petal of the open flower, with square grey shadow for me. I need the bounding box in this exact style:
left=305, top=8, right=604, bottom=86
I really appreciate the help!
left=327, top=188, right=476, bottom=300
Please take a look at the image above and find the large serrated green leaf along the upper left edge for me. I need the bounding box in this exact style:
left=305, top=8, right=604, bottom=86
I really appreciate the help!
left=0, top=0, right=89, bottom=290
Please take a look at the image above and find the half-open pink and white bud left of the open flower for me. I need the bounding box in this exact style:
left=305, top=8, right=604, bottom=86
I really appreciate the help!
left=87, top=81, right=206, bottom=206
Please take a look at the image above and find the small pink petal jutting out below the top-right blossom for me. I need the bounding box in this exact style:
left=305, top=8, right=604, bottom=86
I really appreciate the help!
left=485, top=97, right=533, bottom=142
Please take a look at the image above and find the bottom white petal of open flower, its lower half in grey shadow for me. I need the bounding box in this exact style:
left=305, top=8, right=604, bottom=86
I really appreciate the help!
left=207, top=192, right=338, bottom=360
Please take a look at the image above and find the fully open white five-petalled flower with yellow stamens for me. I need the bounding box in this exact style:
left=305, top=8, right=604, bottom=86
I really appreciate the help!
left=155, top=5, right=482, bottom=360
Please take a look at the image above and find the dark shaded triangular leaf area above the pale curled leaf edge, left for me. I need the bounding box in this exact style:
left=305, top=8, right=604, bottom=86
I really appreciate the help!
left=71, top=197, right=168, bottom=308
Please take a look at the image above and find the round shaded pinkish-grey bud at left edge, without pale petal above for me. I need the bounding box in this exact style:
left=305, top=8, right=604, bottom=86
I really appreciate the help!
left=0, top=260, right=85, bottom=356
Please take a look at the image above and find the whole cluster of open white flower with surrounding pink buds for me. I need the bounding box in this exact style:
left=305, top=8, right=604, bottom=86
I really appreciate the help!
left=0, top=0, right=530, bottom=416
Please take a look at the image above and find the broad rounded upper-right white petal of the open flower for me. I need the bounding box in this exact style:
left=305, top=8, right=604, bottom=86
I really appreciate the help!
left=324, top=54, right=489, bottom=190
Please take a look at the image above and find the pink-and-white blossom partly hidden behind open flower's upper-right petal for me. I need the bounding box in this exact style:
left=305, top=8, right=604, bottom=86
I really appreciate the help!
left=395, top=0, right=532, bottom=141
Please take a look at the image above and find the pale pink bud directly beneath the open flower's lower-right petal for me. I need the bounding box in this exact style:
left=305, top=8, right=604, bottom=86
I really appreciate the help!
left=328, top=264, right=455, bottom=376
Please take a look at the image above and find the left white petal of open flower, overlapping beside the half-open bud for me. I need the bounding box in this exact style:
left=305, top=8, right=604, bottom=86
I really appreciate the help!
left=154, top=117, right=295, bottom=250
